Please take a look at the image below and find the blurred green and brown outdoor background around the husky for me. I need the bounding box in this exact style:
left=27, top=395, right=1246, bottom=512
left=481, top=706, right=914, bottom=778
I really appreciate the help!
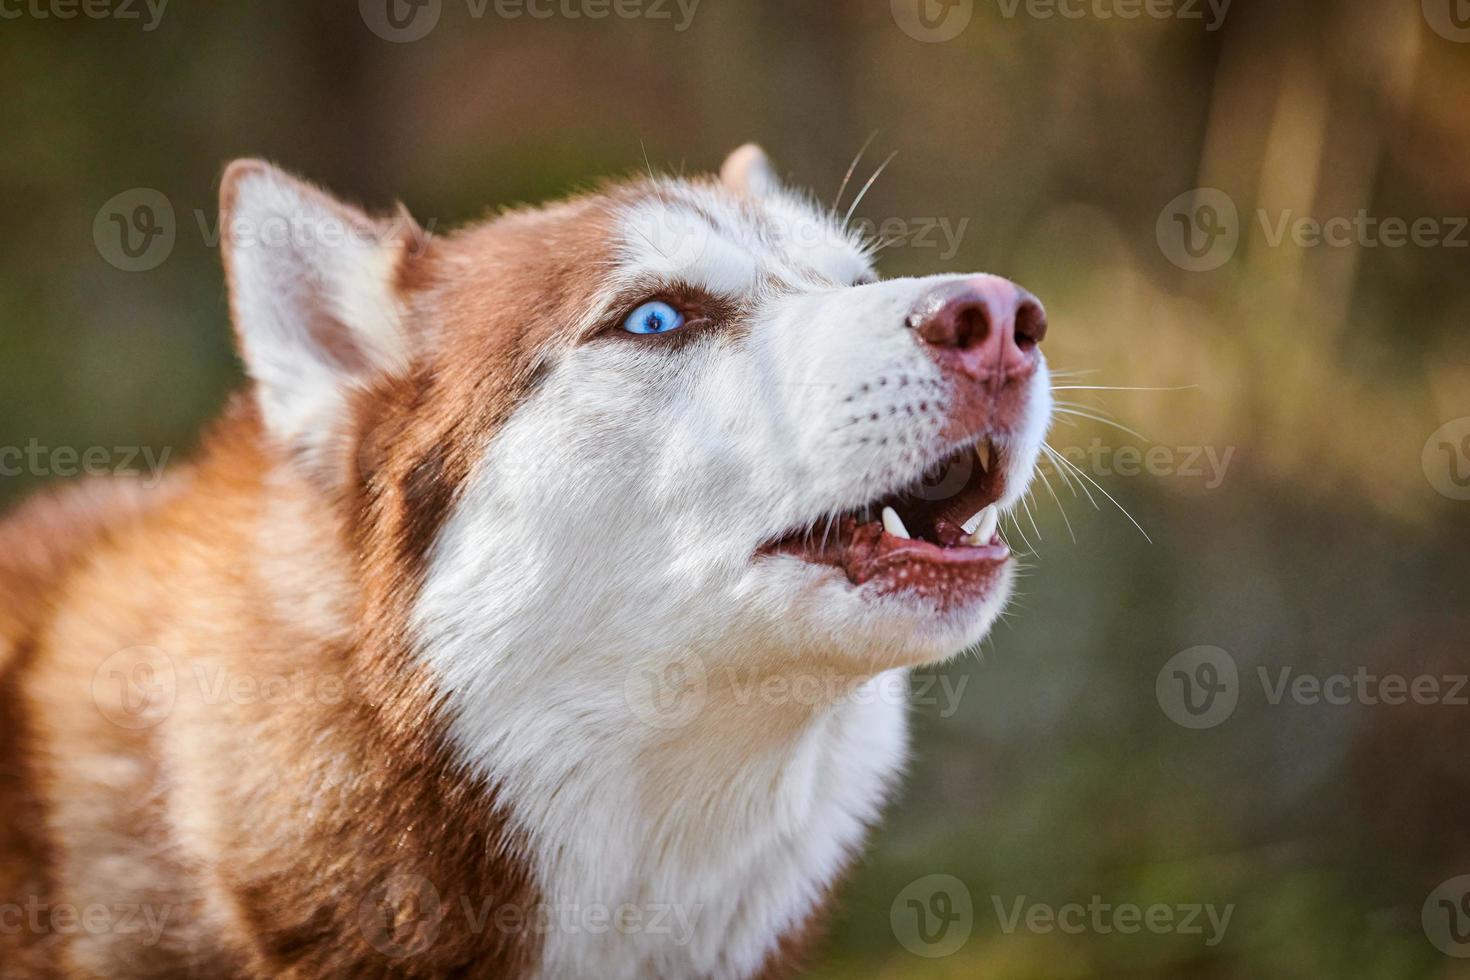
left=0, top=0, right=1470, bottom=980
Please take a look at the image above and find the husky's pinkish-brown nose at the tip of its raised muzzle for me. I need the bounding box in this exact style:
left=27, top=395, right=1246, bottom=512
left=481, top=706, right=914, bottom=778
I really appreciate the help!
left=908, top=276, right=1047, bottom=383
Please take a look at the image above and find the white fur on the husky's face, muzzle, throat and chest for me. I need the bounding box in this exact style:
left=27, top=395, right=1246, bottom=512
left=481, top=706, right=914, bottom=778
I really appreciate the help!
left=413, top=184, right=1050, bottom=977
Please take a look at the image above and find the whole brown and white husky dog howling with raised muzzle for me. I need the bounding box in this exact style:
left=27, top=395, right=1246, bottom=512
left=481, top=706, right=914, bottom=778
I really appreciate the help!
left=0, top=147, right=1051, bottom=980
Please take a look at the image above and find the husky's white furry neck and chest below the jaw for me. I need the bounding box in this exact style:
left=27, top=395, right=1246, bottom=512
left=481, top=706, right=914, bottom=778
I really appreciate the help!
left=429, top=643, right=907, bottom=979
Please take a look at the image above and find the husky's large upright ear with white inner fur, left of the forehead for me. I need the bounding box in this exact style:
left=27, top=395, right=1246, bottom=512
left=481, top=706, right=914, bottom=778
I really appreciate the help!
left=219, top=160, right=422, bottom=472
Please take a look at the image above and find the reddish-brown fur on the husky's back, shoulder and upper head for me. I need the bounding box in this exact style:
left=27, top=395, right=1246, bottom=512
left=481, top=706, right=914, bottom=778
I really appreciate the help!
left=0, top=165, right=829, bottom=977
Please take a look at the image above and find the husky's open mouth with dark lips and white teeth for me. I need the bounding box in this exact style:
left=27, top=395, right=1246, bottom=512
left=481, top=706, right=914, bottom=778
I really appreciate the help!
left=766, top=438, right=1010, bottom=605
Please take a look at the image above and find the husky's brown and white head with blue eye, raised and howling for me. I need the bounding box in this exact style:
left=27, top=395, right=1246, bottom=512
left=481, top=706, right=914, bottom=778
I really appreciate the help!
left=223, top=147, right=1051, bottom=734
